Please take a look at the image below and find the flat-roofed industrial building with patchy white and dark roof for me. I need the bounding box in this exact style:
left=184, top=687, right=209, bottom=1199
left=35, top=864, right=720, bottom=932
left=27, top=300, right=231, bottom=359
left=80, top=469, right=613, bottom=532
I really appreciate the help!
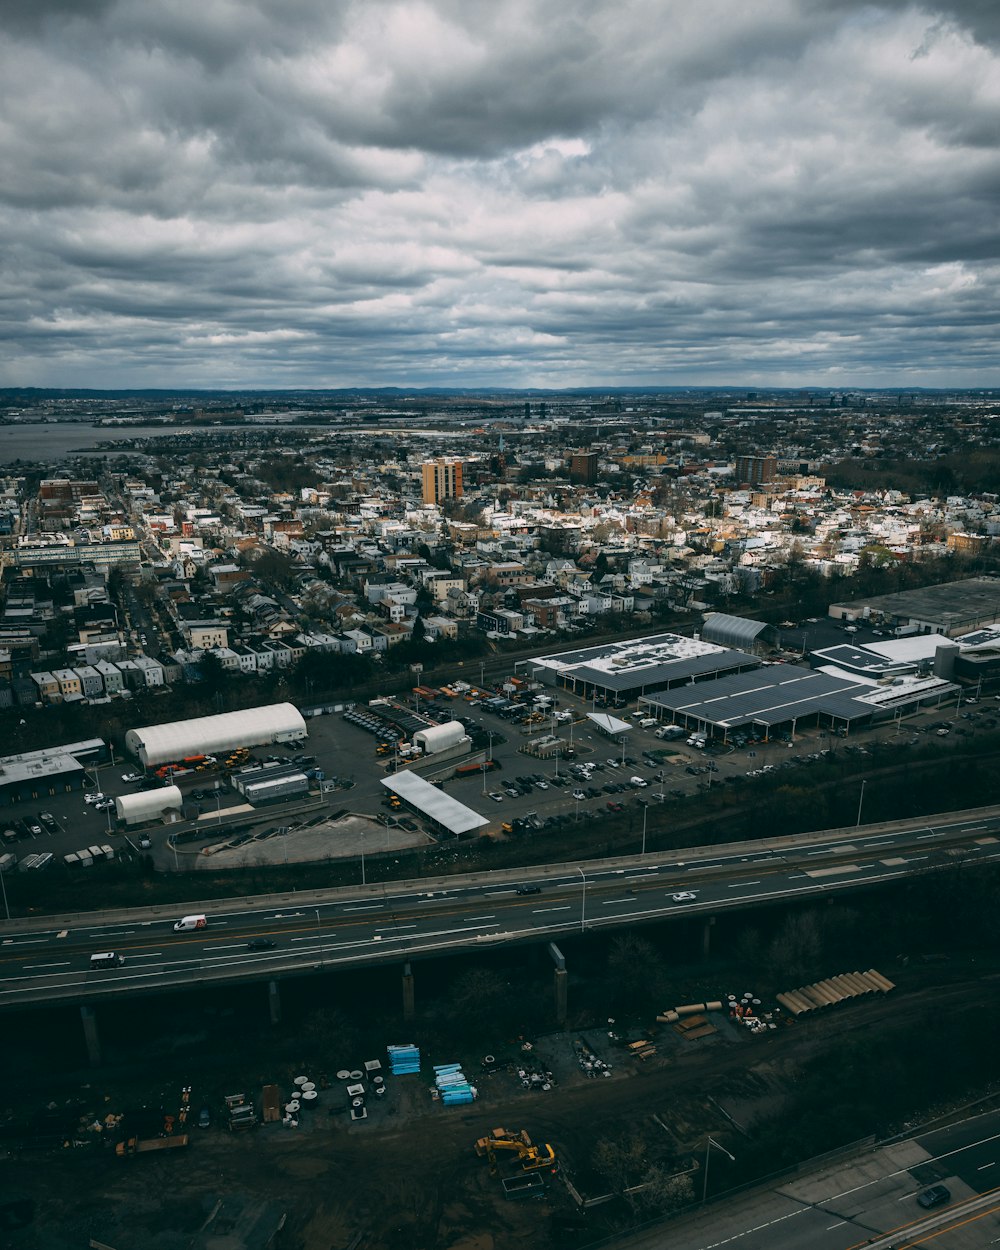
left=519, top=635, right=760, bottom=708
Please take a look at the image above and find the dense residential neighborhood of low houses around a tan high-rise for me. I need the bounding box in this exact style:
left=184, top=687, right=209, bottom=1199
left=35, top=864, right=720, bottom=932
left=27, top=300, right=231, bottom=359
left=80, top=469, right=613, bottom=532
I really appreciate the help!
left=0, top=394, right=1000, bottom=706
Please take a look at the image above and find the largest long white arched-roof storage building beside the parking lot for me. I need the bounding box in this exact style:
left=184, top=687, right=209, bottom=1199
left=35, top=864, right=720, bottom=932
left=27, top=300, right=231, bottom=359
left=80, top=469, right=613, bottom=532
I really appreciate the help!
left=125, top=704, right=308, bottom=769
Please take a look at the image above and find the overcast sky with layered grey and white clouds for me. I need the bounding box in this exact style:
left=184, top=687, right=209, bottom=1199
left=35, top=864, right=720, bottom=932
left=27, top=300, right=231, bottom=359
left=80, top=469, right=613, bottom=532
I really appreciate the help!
left=0, top=0, right=1000, bottom=388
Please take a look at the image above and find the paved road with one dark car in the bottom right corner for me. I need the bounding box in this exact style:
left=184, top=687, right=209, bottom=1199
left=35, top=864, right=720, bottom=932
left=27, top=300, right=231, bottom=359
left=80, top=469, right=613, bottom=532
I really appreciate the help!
left=615, top=1111, right=1000, bottom=1250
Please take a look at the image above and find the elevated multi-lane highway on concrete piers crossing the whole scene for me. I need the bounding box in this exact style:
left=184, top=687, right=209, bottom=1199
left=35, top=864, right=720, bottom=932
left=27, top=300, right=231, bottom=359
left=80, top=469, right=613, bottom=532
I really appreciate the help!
left=0, top=809, right=1000, bottom=1008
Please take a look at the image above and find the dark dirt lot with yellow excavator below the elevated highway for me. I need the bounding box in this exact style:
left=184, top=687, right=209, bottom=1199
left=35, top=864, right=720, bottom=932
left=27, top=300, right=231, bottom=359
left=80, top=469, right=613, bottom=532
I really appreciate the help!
left=0, top=969, right=983, bottom=1250
